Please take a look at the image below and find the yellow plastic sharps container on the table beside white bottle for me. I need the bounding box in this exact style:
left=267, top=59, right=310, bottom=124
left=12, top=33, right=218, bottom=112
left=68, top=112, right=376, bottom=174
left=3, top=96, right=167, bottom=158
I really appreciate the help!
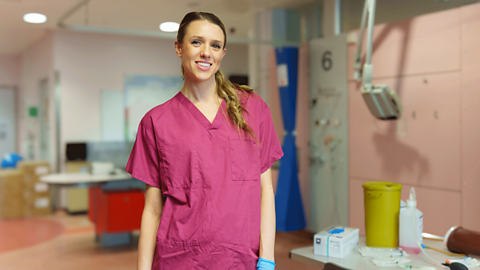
left=363, top=182, right=402, bottom=247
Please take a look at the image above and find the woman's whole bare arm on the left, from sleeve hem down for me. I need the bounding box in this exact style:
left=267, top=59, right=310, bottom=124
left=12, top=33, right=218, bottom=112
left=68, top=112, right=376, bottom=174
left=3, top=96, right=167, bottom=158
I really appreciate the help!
left=137, top=184, right=163, bottom=270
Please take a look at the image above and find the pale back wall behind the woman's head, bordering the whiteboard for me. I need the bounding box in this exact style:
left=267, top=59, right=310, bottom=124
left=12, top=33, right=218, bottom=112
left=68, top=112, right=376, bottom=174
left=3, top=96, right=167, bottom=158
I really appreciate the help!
left=54, top=31, right=248, bottom=169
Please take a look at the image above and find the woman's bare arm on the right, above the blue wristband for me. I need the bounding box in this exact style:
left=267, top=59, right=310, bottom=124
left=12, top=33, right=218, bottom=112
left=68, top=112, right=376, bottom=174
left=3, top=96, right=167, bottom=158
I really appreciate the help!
left=260, top=169, right=275, bottom=261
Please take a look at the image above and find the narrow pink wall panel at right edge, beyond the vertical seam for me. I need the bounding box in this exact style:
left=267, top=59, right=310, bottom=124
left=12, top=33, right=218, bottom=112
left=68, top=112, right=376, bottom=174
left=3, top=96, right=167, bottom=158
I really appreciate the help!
left=460, top=4, right=480, bottom=231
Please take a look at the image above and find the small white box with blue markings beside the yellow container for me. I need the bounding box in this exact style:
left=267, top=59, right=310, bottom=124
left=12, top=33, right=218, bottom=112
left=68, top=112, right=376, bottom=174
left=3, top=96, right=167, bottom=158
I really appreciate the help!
left=313, top=226, right=359, bottom=258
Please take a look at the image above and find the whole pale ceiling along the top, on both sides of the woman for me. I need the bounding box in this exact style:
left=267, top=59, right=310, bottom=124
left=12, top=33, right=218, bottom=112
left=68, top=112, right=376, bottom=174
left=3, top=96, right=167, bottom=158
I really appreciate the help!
left=0, top=0, right=478, bottom=55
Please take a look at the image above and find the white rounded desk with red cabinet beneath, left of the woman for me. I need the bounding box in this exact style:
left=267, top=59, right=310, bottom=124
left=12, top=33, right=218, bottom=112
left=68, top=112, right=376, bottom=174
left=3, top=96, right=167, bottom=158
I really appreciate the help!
left=40, top=172, right=145, bottom=247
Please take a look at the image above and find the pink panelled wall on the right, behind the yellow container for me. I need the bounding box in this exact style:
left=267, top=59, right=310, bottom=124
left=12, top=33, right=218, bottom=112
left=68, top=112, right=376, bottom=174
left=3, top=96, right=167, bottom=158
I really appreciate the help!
left=349, top=4, right=480, bottom=235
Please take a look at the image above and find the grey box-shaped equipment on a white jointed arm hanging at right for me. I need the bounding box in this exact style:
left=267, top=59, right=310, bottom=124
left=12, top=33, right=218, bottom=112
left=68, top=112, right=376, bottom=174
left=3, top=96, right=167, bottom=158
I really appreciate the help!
left=354, top=0, right=402, bottom=120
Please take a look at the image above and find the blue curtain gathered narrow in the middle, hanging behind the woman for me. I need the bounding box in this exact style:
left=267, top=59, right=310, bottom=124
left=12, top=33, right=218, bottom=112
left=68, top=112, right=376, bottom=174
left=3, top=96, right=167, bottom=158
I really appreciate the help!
left=275, top=47, right=306, bottom=231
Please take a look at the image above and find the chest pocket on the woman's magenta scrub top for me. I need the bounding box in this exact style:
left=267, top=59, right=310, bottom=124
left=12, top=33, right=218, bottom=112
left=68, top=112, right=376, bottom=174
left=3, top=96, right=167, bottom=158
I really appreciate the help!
left=229, top=138, right=260, bottom=181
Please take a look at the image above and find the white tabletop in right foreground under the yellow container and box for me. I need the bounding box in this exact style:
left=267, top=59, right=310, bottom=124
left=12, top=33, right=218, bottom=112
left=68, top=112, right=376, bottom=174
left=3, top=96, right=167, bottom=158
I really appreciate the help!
left=290, top=236, right=478, bottom=270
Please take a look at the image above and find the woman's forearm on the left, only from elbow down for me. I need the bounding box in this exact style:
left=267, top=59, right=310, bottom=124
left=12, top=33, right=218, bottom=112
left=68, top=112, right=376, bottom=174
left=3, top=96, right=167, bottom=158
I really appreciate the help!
left=137, top=209, right=160, bottom=270
